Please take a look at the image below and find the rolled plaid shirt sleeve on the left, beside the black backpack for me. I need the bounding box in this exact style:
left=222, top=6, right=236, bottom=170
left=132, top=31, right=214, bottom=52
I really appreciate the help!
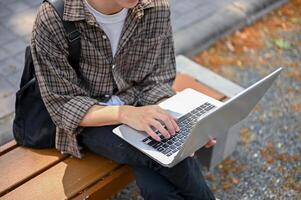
left=31, top=4, right=98, bottom=132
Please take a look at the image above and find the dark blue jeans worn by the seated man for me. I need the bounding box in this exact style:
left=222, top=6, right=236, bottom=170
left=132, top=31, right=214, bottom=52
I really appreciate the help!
left=78, top=126, right=215, bottom=200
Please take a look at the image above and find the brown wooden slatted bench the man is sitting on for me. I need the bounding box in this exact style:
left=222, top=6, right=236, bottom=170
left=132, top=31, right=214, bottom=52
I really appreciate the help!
left=0, top=74, right=225, bottom=200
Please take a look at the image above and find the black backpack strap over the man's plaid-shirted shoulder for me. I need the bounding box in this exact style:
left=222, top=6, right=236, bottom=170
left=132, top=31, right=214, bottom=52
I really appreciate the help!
left=44, top=0, right=81, bottom=76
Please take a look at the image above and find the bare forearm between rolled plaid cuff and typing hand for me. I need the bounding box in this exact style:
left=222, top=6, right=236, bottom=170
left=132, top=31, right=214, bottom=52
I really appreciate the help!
left=79, top=105, right=129, bottom=127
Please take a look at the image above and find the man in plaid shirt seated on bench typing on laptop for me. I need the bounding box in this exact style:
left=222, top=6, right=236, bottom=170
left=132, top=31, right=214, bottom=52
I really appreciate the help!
left=31, top=0, right=215, bottom=199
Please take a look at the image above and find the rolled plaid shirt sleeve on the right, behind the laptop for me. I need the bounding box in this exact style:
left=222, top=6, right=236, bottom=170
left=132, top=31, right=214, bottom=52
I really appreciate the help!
left=138, top=17, right=176, bottom=105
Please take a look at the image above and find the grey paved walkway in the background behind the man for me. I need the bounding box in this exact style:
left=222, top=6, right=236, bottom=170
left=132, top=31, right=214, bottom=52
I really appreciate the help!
left=0, top=0, right=239, bottom=144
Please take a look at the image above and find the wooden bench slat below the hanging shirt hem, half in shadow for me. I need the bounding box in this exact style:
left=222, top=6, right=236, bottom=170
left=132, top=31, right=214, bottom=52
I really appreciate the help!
left=2, top=153, right=119, bottom=200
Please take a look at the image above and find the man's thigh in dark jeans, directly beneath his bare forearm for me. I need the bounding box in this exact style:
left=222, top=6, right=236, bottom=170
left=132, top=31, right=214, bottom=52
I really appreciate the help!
left=78, top=125, right=159, bottom=168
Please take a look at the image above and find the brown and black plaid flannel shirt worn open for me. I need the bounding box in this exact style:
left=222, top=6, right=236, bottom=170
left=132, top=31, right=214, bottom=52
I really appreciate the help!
left=31, top=0, right=176, bottom=158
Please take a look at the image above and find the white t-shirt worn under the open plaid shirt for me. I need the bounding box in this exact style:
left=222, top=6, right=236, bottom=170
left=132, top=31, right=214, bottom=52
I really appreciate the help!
left=84, top=0, right=128, bottom=105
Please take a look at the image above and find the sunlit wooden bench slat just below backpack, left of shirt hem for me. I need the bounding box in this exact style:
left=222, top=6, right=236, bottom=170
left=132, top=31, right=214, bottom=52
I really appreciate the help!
left=0, top=147, right=66, bottom=196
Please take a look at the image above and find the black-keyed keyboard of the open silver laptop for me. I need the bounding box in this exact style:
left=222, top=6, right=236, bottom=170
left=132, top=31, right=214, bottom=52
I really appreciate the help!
left=142, top=102, right=215, bottom=156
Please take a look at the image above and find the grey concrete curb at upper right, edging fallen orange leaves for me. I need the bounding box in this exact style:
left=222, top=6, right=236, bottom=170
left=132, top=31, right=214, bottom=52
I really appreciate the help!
left=174, top=0, right=288, bottom=56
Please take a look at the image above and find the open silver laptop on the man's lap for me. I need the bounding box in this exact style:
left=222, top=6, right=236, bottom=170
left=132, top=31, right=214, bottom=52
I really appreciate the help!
left=113, top=68, right=282, bottom=167
